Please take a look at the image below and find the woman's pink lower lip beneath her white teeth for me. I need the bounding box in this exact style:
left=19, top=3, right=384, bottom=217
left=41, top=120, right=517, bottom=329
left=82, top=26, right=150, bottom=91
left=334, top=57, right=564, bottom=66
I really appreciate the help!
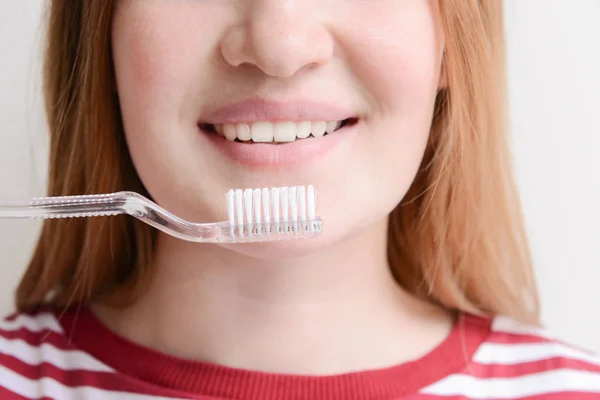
left=200, top=123, right=358, bottom=168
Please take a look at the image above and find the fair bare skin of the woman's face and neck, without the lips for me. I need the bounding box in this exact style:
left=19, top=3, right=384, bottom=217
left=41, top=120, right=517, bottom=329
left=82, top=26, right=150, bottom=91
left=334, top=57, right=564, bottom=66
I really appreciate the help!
left=95, top=0, right=452, bottom=374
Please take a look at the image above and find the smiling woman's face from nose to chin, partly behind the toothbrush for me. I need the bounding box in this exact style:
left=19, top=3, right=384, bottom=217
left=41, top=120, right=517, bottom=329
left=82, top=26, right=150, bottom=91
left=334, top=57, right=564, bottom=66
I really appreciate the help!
left=112, top=0, right=443, bottom=256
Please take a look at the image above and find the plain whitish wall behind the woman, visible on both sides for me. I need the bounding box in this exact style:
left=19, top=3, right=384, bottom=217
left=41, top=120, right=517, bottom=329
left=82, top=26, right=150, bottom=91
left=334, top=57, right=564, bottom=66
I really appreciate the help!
left=0, top=0, right=600, bottom=352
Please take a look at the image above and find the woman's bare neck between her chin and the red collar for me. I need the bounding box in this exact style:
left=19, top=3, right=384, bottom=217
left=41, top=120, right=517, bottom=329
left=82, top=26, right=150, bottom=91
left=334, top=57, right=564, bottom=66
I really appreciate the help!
left=96, top=222, right=450, bottom=375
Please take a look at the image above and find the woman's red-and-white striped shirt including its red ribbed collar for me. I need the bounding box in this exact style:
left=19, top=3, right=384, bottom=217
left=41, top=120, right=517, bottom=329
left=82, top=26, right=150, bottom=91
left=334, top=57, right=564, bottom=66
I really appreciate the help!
left=0, top=307, right=600, bottom=400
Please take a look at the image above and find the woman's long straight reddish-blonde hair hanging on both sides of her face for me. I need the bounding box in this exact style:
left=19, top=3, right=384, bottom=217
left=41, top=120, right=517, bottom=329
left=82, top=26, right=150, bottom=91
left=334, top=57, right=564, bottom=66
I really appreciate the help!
left=16, top=0, right=539, bottom=323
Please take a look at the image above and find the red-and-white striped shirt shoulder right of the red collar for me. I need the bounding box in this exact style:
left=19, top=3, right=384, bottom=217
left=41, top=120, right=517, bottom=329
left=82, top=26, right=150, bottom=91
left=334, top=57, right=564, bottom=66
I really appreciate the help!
left=424, top=316, right=600, bottom=400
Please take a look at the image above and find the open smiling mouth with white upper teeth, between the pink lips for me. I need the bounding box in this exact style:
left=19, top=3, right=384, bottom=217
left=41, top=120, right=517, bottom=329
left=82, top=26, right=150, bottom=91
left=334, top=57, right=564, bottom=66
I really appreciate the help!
left=198, top=118, right=358, bottom=144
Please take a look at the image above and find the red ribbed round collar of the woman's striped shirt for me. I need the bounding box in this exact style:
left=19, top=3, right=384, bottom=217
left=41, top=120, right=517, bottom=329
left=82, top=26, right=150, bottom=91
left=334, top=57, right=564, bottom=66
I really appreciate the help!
left=60, top=307, right=491, bottom=400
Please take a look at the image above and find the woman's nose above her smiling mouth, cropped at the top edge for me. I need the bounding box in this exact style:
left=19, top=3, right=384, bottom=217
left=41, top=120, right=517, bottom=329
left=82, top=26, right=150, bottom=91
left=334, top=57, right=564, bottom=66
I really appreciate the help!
left=220, top=0, right=334, bottom=78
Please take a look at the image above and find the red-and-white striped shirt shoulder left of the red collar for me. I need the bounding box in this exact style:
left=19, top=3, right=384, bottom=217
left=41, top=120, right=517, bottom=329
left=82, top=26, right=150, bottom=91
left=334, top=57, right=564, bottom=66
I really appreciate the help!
left=0, top=307, right=188, bottom=400
